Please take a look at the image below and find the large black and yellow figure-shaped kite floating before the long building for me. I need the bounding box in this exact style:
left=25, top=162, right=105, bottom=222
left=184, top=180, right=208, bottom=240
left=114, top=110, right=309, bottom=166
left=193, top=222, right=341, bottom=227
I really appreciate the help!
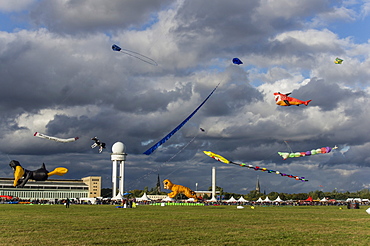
left=9, top=160, right=68, bottom=188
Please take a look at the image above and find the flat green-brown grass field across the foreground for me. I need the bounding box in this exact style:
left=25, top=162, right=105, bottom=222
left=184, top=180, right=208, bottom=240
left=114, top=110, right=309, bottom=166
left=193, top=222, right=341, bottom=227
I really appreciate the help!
left=0, top=204, right=370, bottom=245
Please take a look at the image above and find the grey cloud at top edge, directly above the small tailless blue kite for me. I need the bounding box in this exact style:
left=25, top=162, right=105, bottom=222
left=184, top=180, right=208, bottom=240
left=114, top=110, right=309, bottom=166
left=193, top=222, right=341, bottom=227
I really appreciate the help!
left=172, top=0, right=330, bottom=57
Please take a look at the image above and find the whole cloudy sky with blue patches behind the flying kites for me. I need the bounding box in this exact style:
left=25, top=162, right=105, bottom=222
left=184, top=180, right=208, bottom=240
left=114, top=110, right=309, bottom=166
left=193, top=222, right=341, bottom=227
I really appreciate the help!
left=0, top=0, right=370, bottom=194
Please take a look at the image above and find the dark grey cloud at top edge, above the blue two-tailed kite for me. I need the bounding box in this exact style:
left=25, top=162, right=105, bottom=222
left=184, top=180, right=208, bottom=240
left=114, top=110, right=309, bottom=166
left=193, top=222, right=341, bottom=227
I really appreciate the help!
left=30, top=0, right=172, bottom=35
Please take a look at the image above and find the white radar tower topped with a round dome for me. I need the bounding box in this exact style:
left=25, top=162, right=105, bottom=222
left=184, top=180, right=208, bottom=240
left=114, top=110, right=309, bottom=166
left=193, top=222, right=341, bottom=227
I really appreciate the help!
left=111, top=142, right=127, bottom=199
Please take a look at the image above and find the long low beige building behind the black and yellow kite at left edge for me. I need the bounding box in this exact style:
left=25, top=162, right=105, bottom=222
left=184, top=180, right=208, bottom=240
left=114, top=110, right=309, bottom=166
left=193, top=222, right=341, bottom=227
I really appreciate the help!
left=0, top=176, right=101, bottom=200
